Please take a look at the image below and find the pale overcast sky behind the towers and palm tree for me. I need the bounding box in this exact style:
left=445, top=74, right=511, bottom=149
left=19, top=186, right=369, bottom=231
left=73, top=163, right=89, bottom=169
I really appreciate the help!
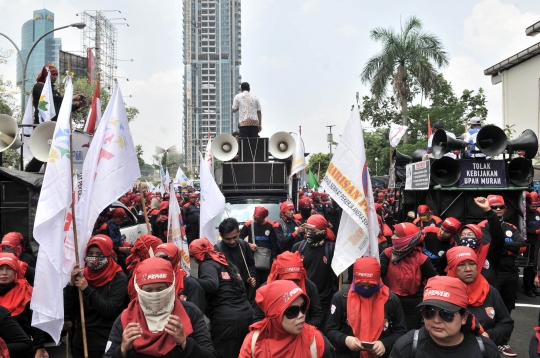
left=0, top=0, right=540, bottom=164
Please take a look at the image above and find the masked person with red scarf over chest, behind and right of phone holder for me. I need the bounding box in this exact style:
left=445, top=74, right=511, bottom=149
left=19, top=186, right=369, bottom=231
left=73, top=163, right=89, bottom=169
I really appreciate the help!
left=380, top=223, right=437, bottom=329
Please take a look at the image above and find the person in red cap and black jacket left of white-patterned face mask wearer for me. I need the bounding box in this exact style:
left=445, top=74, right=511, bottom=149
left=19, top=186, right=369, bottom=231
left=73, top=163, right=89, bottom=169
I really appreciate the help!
left=422, top=218, right=461, bottom=276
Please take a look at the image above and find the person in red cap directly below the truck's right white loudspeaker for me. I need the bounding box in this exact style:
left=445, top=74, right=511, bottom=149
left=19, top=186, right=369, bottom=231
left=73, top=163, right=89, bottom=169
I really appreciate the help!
left=274, top=201, right=305, bottom=253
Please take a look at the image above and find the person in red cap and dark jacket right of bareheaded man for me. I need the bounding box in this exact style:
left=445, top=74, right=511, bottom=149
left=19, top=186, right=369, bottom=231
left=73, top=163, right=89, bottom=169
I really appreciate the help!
left=240, top=206, right=278, bottom=301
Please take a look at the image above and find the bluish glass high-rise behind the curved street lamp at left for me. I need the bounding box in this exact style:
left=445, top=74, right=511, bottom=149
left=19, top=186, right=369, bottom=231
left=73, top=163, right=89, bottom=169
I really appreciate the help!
left=17, top=9, right=62, bottom=98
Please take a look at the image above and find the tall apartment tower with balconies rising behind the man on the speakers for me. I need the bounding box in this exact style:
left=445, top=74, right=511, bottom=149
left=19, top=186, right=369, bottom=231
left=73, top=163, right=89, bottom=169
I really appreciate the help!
left=183, top=0, right=242, bottom=172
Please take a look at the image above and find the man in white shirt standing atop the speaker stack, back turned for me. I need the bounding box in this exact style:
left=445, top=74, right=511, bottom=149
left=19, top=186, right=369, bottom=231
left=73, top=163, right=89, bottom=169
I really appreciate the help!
left=232, top=82, right=262, bottom=138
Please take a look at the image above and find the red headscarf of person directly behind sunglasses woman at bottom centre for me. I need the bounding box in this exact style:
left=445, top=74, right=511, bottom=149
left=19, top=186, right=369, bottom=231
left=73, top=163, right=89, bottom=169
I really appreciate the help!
left=266, top=251, right=307, bottom=292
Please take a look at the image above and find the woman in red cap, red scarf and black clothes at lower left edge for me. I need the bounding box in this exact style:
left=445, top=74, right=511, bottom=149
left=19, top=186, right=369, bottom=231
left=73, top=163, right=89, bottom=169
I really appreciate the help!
left=0, top=253, right=45, bottom=358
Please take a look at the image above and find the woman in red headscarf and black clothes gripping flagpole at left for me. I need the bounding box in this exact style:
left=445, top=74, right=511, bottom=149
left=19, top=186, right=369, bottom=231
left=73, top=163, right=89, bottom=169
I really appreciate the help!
left=64, top=235, right=127, bottom=358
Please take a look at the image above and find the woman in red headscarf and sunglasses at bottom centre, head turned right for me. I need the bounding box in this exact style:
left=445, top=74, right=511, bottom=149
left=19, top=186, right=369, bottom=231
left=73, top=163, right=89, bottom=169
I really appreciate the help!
left=239, top=280, right=335, bottom=358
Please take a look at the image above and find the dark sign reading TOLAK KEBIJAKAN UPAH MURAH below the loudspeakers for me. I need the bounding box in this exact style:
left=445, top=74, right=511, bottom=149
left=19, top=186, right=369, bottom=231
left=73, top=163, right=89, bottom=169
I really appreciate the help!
left=459, top=160, right=506, bottom=188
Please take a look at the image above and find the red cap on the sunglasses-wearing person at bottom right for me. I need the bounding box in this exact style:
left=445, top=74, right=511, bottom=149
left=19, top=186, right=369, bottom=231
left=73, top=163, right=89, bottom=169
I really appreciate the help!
left=416, top=276, right=469, bottom=312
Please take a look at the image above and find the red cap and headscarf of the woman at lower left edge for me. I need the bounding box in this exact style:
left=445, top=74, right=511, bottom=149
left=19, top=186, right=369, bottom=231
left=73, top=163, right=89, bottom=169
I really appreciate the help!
left=0, top=252, right=32, bottom=316
